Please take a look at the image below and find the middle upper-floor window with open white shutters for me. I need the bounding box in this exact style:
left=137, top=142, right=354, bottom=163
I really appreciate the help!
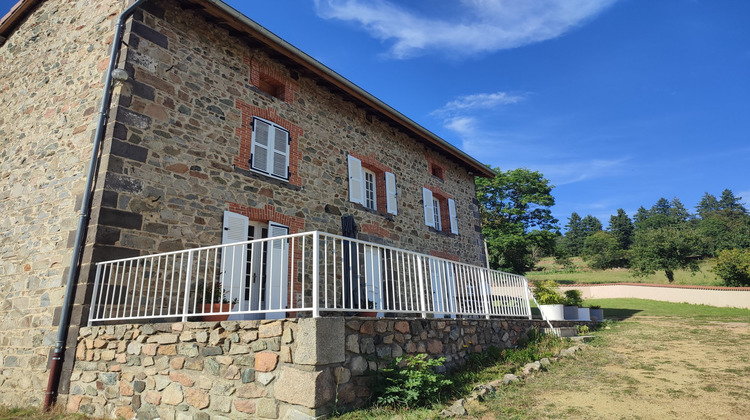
left=347, top=155, right=398, bottom=214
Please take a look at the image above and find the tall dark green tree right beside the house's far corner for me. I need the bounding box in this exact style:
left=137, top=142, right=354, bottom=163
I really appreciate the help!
left=476, top=168, right=557, bottom=274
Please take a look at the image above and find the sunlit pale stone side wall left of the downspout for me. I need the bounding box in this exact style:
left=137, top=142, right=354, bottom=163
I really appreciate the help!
left=0, top=0, right=125, bottom=405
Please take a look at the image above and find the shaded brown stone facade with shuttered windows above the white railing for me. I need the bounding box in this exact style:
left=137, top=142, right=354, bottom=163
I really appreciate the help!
left=92, top=0, right=483, bottom=288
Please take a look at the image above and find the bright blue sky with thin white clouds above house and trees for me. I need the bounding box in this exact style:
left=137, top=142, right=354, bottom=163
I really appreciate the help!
left=0, top=0, right=750, bottom=230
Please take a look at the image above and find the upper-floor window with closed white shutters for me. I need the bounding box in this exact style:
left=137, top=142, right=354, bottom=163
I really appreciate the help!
left=250, top=117, right=290, bottom=180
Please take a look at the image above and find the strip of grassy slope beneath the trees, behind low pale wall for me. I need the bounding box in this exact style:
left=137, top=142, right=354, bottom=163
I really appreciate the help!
left=526, top=257, right=724, bottom=286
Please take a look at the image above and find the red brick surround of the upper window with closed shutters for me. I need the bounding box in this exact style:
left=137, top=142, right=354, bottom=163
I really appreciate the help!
left=233, top=99, right=304, bottom=186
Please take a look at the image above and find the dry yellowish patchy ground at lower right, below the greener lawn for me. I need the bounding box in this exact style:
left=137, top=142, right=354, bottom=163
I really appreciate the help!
left=471, top=317, right=750, bottom=419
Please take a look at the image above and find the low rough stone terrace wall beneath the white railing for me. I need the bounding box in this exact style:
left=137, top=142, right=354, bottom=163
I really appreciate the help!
left=66, top=317, right=576, bottom=419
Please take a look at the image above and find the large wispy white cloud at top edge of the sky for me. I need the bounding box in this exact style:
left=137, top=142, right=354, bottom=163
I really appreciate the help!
left=314, top=0, right=616, bottom=58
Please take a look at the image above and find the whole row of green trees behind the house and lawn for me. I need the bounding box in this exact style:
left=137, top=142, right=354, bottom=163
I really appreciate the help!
left=476, top=168, right=750, bottom=286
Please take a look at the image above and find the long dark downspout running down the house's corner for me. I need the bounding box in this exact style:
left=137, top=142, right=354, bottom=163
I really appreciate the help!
left=44, top=0, right=151, bottom=411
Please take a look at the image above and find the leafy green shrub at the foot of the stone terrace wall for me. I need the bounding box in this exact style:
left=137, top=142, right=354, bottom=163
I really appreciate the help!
left=374, top=353, right=452, bottom=407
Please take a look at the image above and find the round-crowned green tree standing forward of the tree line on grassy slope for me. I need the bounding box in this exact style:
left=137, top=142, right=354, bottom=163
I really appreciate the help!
left=630, top=225, right=702, bottom=283
